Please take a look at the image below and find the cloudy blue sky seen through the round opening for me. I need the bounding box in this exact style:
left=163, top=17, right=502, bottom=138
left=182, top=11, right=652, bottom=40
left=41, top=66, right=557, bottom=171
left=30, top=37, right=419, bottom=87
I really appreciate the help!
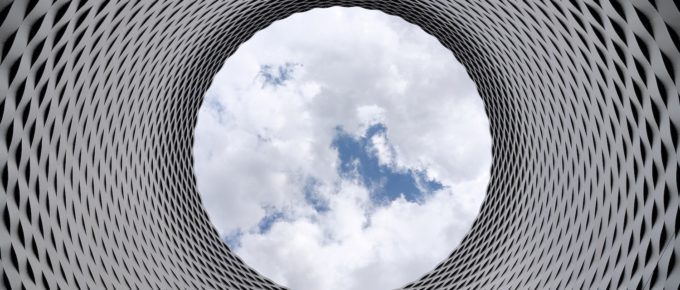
left=194, top=7, right=491, bottom=290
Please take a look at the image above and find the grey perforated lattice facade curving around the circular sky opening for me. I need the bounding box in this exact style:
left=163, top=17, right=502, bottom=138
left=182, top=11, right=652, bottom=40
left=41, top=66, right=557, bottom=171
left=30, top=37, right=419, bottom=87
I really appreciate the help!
left=0, top=0, right=680, bottom=289
